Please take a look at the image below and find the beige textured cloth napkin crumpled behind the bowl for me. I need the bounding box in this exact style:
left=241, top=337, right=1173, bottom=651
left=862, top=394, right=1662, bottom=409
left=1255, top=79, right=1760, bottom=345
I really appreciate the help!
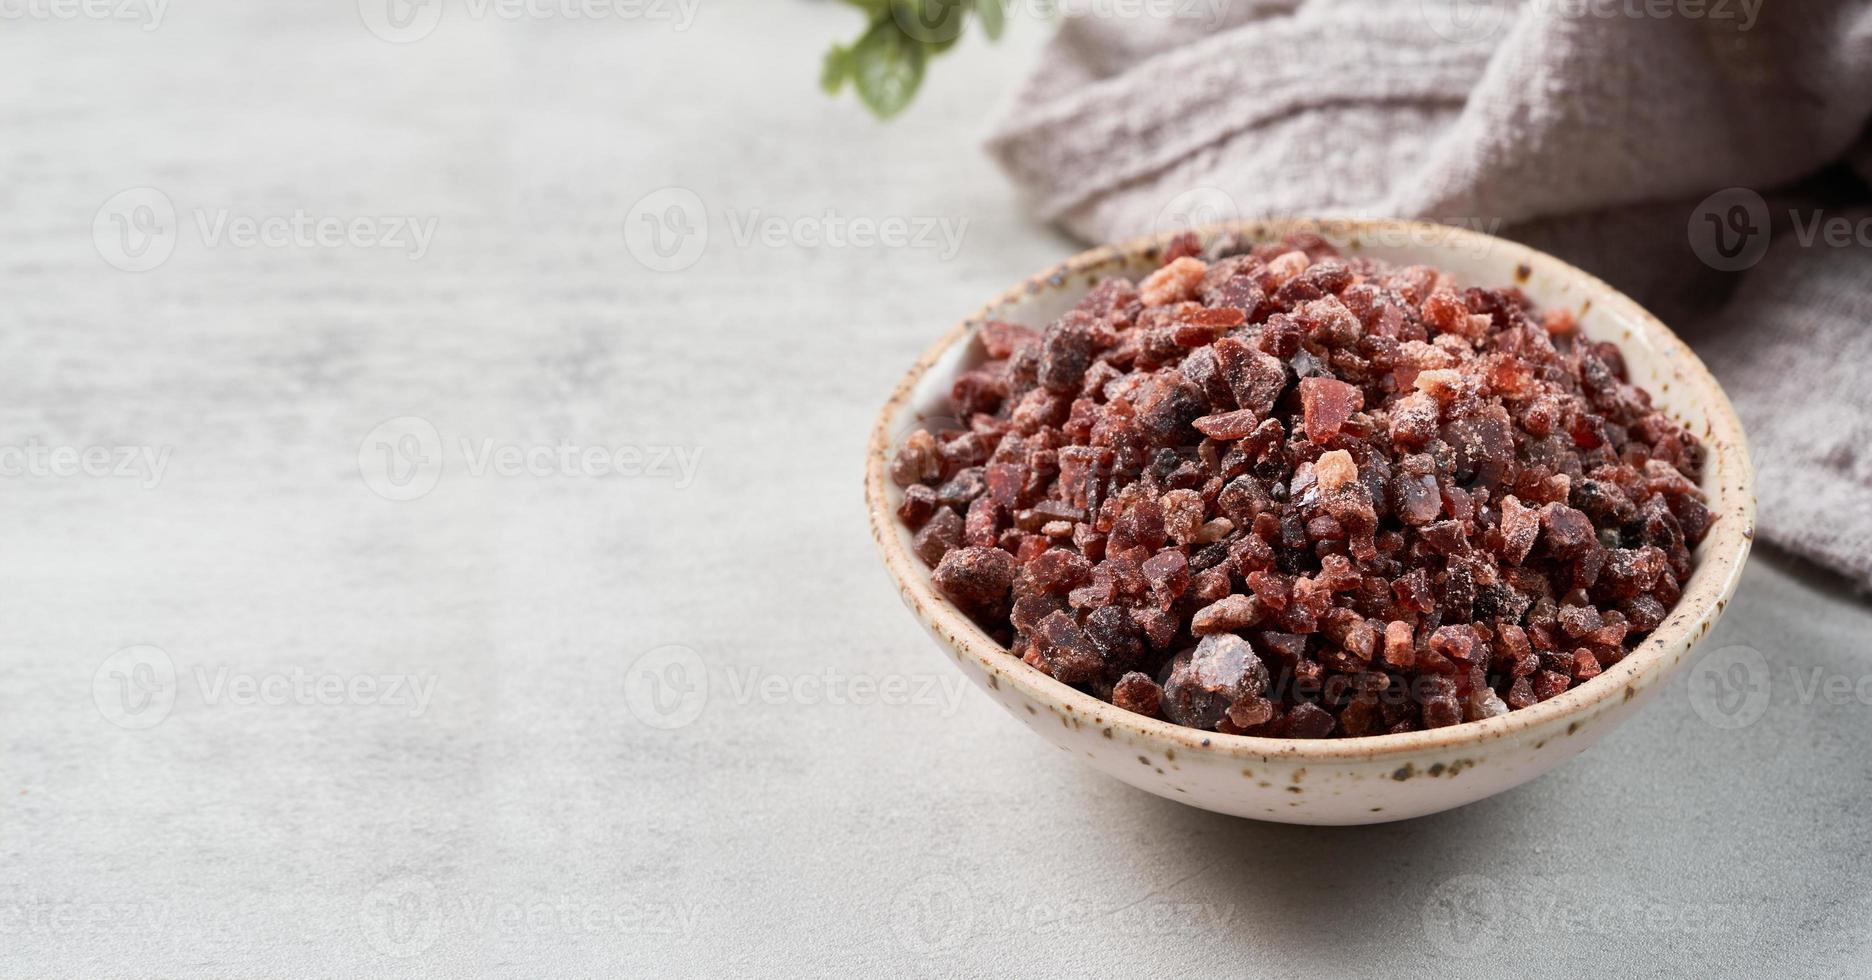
left=988, top=0, right=1872, bottom=585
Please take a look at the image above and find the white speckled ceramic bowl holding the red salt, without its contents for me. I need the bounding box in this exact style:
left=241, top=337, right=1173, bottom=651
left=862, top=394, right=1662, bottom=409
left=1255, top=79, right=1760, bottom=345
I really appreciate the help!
left=865, top=219, right=1754, bottom=825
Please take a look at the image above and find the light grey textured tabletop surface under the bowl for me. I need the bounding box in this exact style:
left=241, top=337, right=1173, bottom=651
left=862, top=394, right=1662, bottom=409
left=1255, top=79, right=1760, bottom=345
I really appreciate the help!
left=0, top=0, right=1872, bottom=976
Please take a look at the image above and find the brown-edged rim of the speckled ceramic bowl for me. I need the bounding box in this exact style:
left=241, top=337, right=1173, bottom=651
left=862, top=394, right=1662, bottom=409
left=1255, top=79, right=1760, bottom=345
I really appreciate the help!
left=865, top=217, right=1754, bottom=761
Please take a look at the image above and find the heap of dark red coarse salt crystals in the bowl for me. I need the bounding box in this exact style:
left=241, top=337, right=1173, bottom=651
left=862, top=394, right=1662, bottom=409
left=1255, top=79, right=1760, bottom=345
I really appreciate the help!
left=889, top=236, right=1715, bottom=739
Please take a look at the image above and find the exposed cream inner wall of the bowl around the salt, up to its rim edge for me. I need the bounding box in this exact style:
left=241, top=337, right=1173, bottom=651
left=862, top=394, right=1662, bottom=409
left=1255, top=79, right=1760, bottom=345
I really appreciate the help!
left=867, top=221, right=1754, bottom=756
